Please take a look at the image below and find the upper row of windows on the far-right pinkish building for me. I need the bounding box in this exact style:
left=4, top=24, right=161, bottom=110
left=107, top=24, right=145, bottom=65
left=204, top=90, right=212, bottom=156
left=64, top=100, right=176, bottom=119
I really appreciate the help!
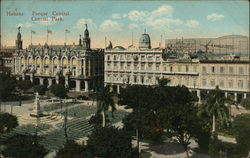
left=202, top=66, right=245, bottom=75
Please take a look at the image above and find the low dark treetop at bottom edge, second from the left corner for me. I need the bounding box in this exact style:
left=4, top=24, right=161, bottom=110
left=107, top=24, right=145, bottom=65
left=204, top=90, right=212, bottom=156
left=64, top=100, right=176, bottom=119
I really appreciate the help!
left=55, top=140, right=94, bottom=158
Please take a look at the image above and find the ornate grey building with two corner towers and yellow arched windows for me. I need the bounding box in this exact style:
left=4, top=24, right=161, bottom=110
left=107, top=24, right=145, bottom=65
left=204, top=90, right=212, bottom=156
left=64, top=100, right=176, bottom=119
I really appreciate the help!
left=12, top=24, right=104, bottom=92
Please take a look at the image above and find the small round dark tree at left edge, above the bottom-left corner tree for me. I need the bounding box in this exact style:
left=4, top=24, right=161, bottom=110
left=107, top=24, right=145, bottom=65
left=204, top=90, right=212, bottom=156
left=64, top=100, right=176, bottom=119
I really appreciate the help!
left=0, top=113, right=18, bottom=133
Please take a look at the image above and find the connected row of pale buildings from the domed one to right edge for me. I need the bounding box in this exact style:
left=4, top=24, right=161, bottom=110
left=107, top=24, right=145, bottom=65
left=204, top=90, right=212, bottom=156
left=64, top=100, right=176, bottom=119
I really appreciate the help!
left=104, top=33, right=249, bottom=102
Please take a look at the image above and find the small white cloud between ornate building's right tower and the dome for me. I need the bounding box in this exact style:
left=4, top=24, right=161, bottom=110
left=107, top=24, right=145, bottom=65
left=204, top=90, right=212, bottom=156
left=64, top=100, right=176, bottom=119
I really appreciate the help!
left=100, top=19, right=122, bottom=31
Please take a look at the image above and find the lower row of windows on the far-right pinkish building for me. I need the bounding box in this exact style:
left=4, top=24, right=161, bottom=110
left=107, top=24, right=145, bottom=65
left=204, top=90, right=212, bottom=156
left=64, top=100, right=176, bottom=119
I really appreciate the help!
left=202, top=79, right=244, bottom=89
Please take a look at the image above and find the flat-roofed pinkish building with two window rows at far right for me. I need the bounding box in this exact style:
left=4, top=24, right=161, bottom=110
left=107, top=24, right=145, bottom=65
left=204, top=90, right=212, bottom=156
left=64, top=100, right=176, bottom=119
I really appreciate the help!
left=199, top=60, right=250, bottom=102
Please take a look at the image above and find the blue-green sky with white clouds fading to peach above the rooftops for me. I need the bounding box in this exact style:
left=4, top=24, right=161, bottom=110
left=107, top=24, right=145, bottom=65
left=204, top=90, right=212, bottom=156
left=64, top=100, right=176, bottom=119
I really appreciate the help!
left=1, top=0, right=249, bottom=48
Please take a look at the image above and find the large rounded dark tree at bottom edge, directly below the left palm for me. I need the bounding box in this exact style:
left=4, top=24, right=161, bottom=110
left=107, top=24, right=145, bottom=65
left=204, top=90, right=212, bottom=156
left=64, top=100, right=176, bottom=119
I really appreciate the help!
left=87, top=127, right=137, bottom=158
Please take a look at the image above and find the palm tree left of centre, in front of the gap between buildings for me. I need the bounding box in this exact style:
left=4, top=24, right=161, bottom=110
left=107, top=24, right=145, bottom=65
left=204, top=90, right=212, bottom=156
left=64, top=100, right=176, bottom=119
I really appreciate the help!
left=96, top=86, right=116, bottom=127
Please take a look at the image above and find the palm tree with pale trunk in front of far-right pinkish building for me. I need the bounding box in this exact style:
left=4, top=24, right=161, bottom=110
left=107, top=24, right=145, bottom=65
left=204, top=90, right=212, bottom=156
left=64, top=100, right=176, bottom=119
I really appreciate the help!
left=199, top=86, right=229, bottom=133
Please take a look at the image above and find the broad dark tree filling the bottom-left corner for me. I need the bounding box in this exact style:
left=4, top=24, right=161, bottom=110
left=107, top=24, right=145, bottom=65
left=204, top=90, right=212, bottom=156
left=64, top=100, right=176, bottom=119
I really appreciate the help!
left=2, top=134, right=48, bottom=158
